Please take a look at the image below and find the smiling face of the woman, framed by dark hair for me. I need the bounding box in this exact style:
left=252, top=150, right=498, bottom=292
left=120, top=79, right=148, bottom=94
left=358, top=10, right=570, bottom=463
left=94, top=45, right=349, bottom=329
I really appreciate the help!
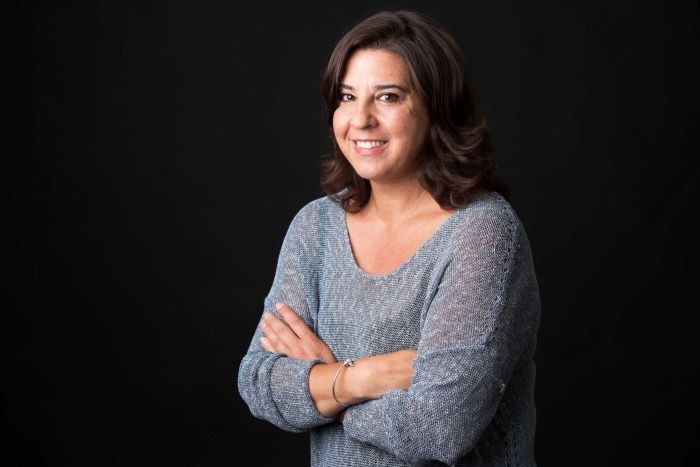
left=333, top=50, right=430, bottom=183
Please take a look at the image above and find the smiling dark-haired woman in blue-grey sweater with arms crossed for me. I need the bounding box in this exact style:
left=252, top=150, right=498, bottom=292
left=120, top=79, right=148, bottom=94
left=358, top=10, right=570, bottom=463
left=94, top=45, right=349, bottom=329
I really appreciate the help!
left=238, top=11, right=540, bottom=466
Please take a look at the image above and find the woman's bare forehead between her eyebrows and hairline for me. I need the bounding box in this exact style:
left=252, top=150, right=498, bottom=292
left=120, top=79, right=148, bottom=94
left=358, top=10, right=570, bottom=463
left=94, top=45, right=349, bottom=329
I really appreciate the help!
left=341, top=49, right=410, bottom=87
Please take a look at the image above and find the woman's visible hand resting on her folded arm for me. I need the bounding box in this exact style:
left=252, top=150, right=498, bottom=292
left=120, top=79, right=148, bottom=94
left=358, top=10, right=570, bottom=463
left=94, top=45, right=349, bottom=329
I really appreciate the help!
left=260, top=303, right=336, bottom=363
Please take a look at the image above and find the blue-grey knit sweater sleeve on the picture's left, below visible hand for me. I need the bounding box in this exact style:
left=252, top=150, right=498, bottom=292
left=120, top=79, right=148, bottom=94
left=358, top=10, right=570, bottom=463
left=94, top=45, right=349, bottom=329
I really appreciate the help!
left=237, top=203, right=333, bottom=432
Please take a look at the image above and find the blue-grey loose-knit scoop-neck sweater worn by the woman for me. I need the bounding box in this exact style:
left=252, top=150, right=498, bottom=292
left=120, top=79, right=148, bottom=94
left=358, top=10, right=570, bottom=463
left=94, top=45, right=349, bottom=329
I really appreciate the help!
left=238, top=192, right=540, bottom=467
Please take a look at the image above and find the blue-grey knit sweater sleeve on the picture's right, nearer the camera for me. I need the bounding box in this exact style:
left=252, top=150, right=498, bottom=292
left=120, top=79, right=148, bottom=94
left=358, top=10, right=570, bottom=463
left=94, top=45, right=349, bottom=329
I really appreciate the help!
left=343, top=206, right=539, bottom=464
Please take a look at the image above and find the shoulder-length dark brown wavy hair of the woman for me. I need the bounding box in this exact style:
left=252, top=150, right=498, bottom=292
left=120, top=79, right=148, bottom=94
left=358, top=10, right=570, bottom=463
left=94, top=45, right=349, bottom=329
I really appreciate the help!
left=321, top=10, right=509, bottom=212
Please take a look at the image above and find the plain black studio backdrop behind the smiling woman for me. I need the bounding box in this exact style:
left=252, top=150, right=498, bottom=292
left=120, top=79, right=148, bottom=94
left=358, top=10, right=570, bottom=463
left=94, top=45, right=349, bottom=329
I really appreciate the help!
left=0, top=0, right=700, bottom=466
